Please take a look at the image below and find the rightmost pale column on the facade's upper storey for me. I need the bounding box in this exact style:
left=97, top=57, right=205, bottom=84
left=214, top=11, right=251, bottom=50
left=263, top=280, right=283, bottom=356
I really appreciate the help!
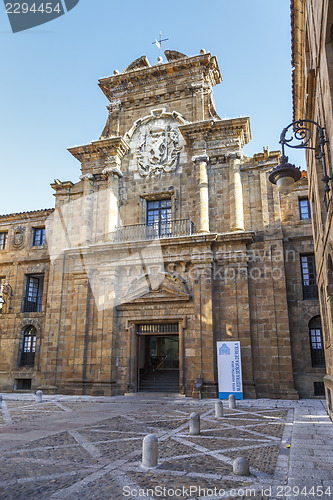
left=229, top=153, right=245, bottom=231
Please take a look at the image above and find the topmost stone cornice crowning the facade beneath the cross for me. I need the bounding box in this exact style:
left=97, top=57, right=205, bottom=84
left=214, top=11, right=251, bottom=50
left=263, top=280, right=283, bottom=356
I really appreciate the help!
left=98, top=53, right=222, bottom=102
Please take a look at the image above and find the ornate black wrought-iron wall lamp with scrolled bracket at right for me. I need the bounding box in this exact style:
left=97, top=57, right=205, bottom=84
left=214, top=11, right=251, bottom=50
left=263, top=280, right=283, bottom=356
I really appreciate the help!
left=269, top=120, right=333, bottom=201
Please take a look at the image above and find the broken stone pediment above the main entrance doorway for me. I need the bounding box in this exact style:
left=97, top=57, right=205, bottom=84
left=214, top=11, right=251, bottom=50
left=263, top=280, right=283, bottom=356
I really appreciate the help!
left=121, top=273, right=191, bottom=303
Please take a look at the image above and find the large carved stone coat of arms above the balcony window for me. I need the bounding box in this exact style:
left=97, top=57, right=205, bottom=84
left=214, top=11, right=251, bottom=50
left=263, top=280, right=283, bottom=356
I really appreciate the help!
left=137, top=124, right=181, bottom=177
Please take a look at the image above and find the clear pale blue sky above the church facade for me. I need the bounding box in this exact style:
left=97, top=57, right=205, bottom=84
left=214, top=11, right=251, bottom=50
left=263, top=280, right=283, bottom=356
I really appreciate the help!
left=0, top=0, right=305, bottom=214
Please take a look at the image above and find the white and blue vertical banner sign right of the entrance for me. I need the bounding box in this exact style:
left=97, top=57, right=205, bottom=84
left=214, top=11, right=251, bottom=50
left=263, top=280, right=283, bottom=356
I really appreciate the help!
left=217, top=341, right=243, bottom=399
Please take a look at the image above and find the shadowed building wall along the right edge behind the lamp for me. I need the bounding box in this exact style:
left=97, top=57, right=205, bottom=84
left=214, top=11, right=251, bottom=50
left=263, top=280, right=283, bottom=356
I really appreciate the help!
left=291, top=0, right=333, bottom=419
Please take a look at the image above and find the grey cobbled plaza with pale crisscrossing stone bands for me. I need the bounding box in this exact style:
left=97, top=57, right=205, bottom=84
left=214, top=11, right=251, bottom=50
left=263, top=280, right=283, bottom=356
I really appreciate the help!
left=0, top=394, right=333, bottom=500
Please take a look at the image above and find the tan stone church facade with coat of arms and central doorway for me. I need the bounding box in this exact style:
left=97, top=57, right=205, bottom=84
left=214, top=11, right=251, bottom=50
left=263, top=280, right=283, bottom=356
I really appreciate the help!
left=0, top=51, right=325, bottom=398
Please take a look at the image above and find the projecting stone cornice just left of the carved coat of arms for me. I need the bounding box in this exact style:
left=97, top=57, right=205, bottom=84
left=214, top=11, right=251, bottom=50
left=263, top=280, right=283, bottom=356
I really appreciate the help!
left=68, top=137, right=129, bottom=163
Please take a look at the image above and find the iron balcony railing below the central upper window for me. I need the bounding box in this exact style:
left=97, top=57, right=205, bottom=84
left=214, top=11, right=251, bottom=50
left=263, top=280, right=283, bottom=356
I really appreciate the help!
left=110, top=219, right=195, bottom=243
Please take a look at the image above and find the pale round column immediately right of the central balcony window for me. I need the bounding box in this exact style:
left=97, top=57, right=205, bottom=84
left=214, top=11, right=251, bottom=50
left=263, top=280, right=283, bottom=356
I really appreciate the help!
left=192, top=155, right=209, bottom=233
